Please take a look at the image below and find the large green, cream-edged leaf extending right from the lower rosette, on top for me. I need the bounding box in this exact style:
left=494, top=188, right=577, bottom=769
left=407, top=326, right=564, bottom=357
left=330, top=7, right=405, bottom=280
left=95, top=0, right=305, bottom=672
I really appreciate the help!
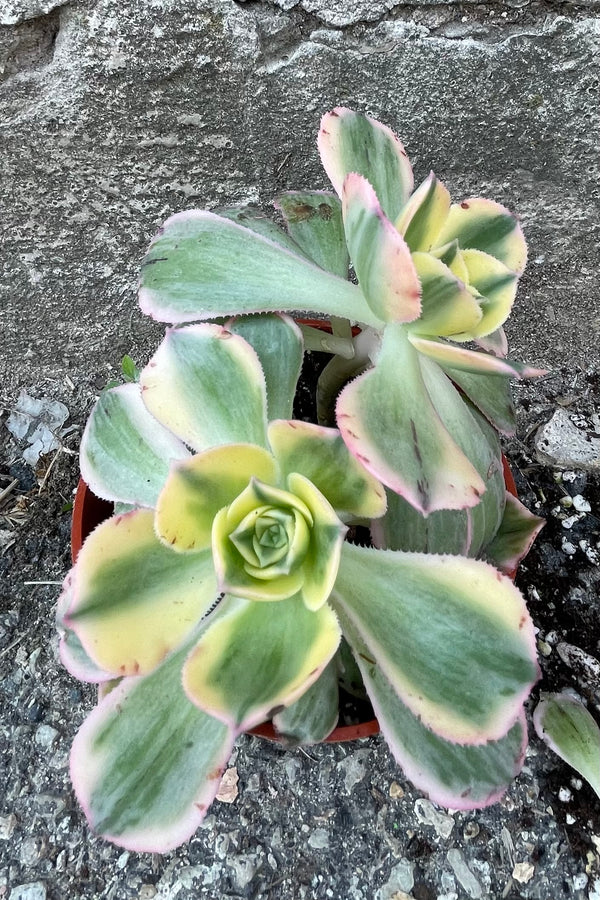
left=331, top=544, right=538, bottom=744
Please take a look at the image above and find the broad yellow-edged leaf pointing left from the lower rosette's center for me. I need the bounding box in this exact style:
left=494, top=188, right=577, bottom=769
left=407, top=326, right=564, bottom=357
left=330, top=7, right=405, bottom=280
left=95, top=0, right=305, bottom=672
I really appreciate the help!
left=65, top=510, right=217, bottom=675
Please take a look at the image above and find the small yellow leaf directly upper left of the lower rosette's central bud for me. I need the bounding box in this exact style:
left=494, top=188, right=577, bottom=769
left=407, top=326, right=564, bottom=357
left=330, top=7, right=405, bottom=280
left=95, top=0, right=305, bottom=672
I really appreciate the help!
left=156, top=444, right=277, bottom=550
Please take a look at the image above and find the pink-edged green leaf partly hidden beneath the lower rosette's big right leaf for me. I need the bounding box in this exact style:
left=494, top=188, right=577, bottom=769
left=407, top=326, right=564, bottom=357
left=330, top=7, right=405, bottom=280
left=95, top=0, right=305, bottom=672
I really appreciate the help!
left=341, top=616, right=527, bottom=809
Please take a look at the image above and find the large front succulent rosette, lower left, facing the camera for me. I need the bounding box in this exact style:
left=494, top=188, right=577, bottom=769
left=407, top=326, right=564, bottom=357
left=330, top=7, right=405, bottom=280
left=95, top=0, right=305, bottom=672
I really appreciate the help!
left=58, top=316, right=538, bottom=852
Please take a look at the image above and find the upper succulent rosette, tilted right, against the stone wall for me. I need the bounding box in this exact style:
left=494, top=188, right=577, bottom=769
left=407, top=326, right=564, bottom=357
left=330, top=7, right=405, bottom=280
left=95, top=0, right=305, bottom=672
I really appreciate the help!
left=140, top=108, right=540, bottom=528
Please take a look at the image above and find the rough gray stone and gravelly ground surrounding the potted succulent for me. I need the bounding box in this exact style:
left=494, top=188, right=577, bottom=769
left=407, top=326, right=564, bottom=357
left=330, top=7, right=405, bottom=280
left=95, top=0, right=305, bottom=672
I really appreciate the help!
left=0, top=0, right=600, bottom=900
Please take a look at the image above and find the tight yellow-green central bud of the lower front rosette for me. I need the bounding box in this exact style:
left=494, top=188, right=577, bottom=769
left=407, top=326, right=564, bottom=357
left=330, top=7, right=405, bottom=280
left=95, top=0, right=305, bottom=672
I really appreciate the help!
left=212, top=475, right=346, bottom=608
